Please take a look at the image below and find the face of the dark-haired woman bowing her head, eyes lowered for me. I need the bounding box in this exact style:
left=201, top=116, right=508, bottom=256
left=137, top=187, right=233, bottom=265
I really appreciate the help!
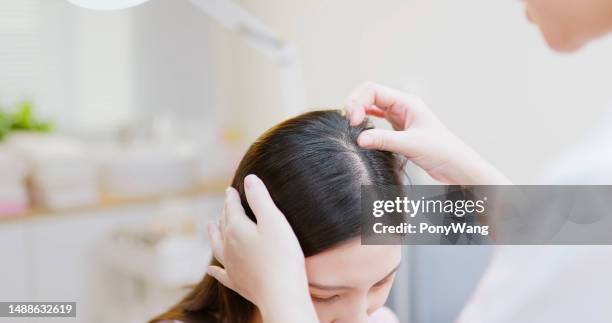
left=306, top=238, right=402, bottom=323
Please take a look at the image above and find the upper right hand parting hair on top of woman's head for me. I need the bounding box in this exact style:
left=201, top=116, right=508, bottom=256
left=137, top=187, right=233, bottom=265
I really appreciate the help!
left=345, top=83, right=510, bottom=185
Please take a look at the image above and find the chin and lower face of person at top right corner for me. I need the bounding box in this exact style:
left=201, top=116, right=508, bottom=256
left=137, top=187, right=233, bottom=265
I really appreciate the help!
left=523, top=0, right=612, bottom=52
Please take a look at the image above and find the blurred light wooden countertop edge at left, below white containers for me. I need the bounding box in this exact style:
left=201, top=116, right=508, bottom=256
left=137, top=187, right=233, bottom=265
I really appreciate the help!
left=0, top=180, right=229, bottom=224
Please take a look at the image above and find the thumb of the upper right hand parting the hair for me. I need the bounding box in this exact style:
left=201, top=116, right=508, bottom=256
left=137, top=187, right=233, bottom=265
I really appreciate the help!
left=357, top=129, right=411, bottom=157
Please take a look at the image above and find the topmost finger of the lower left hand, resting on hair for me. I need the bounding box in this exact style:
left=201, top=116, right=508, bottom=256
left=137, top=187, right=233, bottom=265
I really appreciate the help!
left=244, top=174, right=280, bottom=224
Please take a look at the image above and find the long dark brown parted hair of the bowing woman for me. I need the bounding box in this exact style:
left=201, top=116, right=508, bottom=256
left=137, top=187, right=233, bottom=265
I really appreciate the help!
left=151, top=110, right=400, bottom=323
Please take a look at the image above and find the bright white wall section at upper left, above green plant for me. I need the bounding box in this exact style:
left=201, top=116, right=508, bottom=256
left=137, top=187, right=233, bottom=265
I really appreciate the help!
left=0, top=0, right=133, bottom=129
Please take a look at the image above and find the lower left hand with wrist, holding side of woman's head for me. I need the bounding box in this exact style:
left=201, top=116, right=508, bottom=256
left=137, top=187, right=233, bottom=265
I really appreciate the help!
left=207, top=175, right=318, bottom=323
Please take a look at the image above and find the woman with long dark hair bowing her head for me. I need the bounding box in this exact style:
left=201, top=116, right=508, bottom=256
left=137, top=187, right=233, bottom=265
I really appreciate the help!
left=151, top=110, right=401, bottom=323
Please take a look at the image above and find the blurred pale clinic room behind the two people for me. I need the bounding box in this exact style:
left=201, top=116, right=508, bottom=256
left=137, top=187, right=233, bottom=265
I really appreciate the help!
left=0, top=0, right=612, bottom=323
